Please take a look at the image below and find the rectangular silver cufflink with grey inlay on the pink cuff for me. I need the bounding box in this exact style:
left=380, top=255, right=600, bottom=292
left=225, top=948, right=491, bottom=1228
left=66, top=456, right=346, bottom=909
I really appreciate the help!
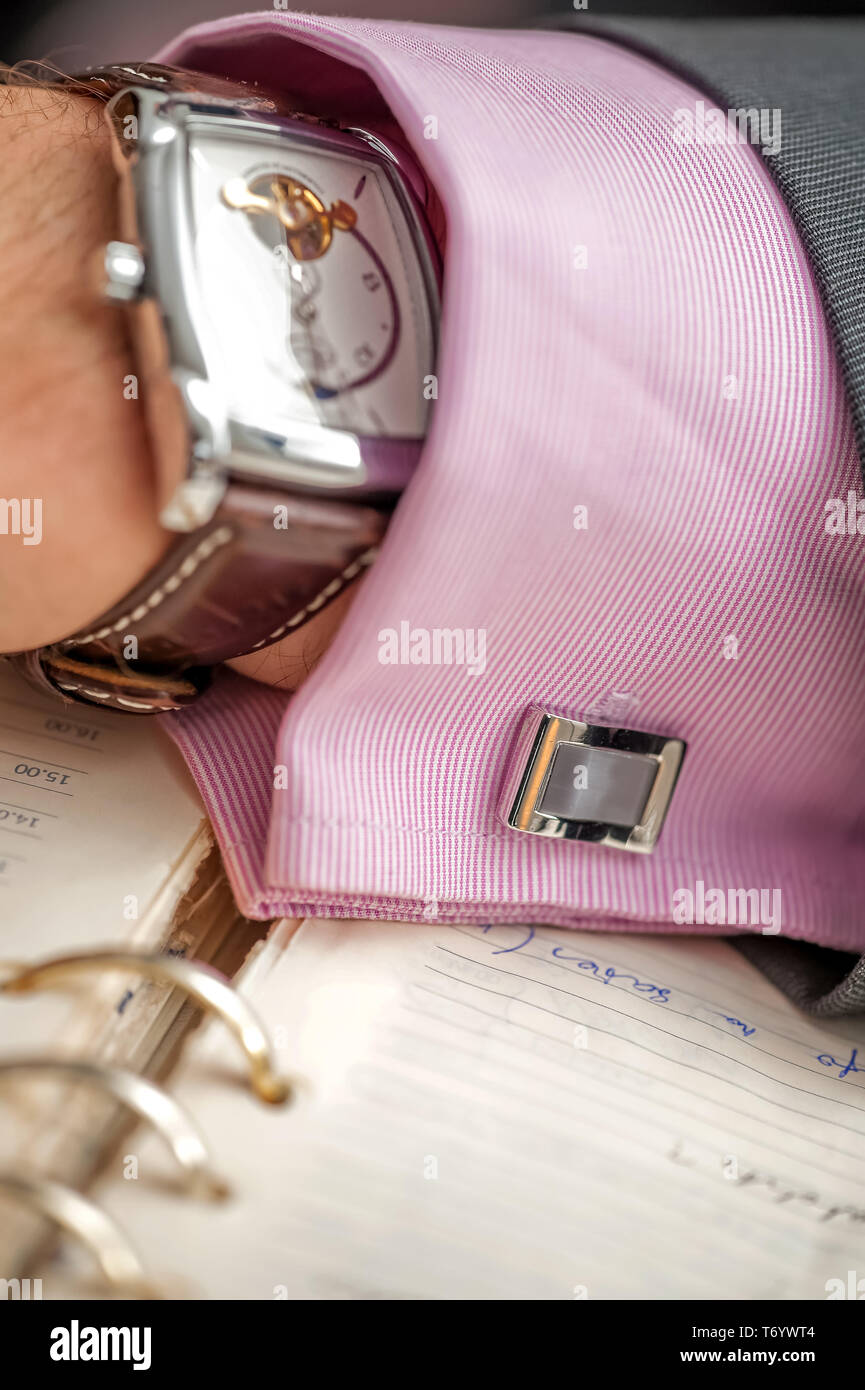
left=499, top=705, right=686, bottom=853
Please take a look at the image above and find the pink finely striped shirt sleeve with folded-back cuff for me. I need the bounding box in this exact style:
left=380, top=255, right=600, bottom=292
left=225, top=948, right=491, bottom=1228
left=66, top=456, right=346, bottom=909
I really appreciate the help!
left=163, top=14, right=865, bottom=948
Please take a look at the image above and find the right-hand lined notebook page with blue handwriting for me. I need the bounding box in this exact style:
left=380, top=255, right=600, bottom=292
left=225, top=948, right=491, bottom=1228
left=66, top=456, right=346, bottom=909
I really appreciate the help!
left=99, top=922, right=865, bottom=1300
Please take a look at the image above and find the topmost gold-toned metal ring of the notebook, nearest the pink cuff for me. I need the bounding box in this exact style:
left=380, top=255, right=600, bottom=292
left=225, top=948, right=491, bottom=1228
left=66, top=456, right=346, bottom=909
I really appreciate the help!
left=0, top=949, right=292, bottom=1105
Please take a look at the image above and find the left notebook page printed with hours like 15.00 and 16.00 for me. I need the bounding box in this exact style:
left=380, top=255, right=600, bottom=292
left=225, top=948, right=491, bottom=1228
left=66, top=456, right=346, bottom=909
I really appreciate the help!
left=0, top=664, right=207, bottom=1055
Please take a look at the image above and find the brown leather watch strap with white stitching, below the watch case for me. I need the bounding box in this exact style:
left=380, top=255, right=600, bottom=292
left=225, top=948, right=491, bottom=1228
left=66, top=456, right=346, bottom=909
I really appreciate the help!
left=11, top=484, right=388, bottom=714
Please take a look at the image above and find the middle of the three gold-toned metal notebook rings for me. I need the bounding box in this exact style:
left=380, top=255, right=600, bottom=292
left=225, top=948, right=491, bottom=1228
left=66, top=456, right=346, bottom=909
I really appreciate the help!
left=0, top=1056, right=231, bottom=1201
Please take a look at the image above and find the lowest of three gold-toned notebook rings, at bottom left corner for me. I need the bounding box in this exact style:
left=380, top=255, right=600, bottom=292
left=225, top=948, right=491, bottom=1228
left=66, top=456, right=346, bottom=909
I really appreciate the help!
left=0, top=1173, right=160, bottom=1298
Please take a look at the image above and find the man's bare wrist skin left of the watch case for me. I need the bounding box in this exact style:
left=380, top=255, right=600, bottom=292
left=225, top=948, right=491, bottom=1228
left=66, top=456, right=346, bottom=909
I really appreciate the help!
left=0, top=86, right=170, bottom=652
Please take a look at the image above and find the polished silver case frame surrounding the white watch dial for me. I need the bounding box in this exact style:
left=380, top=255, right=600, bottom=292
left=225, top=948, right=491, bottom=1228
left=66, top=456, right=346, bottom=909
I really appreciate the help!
left=106, top=85, right=439, bottom=531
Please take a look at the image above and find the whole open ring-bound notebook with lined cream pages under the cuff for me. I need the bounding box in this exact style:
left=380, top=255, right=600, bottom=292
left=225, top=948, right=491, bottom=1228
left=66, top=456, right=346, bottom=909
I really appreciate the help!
left=0, top=661, right=865, bottom=1300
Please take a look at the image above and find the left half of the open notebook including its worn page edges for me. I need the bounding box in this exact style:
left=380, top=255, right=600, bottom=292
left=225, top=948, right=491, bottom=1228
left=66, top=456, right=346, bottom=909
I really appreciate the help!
left=0, top=663, right=264, bottom=1279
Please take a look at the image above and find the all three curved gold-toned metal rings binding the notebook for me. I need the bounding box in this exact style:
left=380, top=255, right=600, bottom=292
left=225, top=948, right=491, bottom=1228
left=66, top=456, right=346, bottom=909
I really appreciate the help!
left=0, top=949, right=293, bottom=1298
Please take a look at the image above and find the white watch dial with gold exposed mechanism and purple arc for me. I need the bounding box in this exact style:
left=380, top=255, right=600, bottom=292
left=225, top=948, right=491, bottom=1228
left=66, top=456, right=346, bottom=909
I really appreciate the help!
left=188, top=120, right=435, bottom=439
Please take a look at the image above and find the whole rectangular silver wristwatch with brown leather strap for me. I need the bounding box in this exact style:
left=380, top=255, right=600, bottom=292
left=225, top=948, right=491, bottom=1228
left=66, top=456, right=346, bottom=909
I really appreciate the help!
left=5, top=64, right=444, bottom=714
